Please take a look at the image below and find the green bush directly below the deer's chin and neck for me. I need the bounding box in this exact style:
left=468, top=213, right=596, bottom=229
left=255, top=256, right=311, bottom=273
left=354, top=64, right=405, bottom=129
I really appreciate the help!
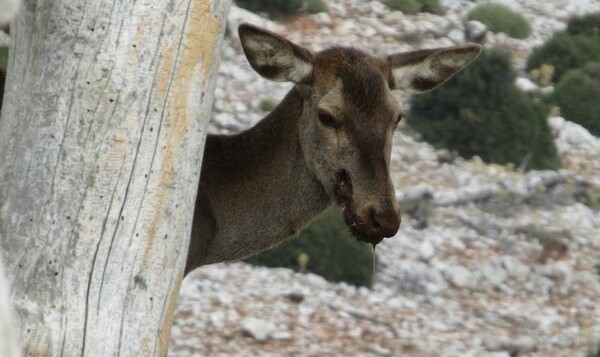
left=246, top=206, right=375, bottom=287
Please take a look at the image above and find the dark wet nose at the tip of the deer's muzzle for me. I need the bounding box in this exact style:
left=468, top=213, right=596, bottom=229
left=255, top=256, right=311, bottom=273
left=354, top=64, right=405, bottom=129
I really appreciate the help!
left=360, top=205, right=401, bottom=237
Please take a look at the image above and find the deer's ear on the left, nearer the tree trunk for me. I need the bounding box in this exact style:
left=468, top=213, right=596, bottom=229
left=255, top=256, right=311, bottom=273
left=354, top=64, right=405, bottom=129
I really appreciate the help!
left=238, top=24, right=313, bottom=84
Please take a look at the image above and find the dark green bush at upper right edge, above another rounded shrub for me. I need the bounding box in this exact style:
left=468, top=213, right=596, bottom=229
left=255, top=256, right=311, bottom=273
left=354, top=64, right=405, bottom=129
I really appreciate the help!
left=527, top=13, right=600, bottom=81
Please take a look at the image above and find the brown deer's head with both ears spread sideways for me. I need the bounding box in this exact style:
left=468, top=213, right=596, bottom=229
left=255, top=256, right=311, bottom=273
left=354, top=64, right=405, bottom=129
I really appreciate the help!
left=239, top=24, right=480, bottom=245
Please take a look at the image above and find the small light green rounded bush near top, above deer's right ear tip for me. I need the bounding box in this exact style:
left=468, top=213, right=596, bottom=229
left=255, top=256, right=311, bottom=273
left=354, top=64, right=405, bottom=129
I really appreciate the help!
left=468, top=3, right=531, bottom=38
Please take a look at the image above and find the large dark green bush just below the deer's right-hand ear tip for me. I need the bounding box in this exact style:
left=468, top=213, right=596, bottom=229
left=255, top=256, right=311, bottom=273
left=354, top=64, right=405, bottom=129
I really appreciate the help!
left=407, top=49, right=560, bottom=169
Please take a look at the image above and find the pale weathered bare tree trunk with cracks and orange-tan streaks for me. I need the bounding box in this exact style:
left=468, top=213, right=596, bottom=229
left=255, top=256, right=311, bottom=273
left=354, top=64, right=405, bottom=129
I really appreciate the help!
left=0, top=0, right=231, bottom=356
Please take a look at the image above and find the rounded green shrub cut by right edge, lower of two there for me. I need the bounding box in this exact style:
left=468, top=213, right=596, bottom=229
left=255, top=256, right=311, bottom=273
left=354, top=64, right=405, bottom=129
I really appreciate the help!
left=554, top=62, right=600, bottom=136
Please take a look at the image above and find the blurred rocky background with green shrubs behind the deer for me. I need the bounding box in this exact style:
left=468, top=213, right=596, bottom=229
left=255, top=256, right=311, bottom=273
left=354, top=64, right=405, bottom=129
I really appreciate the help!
left=169, top=0, right=600, bottom=357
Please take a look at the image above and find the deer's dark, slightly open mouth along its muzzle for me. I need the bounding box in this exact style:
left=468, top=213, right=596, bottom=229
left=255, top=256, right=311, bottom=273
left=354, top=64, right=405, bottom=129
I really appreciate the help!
left=334, top=170, right=384, bottom=247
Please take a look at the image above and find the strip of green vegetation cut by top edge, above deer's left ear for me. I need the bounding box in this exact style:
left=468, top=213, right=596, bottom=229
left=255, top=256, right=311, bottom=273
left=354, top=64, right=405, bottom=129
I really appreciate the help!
left=235, top=0, right=327, bottom=16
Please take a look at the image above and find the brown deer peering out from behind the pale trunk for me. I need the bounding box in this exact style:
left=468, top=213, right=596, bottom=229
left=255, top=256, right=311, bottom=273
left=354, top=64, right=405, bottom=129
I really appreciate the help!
left=185, top=23, right=481, bottom=275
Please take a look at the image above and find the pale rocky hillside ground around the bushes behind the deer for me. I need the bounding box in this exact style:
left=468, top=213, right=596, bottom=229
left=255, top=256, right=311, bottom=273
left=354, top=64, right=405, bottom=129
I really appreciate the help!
left=169, top=0, right=600, bottom=357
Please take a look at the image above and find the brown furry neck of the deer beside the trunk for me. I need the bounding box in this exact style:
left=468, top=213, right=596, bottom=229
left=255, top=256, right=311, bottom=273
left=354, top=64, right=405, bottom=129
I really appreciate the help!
left=201, top=89, right=330, bottom=264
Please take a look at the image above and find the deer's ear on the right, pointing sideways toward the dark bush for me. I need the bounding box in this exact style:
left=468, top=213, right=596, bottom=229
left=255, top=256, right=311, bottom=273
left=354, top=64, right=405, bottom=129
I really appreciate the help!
left=387, top=44, right=481, bottom=94
